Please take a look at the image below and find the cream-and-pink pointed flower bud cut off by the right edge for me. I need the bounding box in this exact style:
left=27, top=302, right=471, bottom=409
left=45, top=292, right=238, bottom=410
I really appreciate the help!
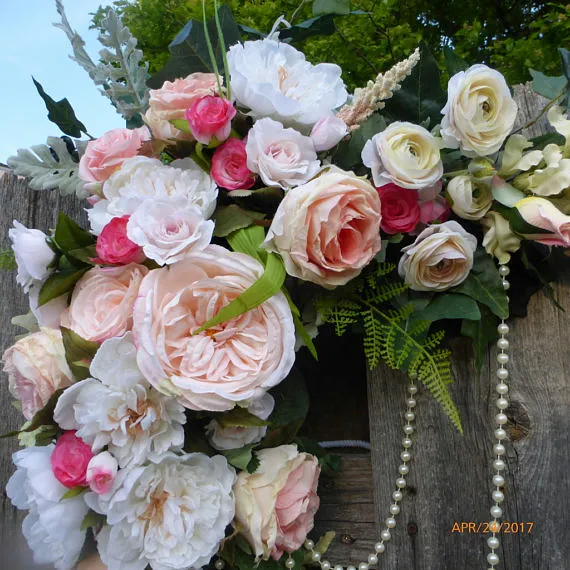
left=513, top=196, right=570, bottom=247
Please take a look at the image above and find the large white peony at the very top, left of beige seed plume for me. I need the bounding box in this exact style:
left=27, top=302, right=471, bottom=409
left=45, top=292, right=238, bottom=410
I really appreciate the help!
left=228, top=39, right=347, bottom=128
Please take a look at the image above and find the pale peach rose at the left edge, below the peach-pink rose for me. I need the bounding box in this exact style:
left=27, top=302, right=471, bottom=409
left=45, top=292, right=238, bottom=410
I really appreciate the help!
left=2, top=328, right=73, bottom=420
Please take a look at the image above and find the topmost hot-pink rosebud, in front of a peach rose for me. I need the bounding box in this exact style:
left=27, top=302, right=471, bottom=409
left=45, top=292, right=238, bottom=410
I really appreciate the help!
left=184, top=95, right=236, bottom=144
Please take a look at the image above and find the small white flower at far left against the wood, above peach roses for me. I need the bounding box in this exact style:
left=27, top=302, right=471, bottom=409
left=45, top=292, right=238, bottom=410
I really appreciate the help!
left=8, top=220, right=55, bottom=293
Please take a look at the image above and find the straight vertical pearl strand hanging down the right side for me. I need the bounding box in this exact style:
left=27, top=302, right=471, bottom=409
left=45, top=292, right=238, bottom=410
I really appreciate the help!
left=487, top=265, right=510, bottom=570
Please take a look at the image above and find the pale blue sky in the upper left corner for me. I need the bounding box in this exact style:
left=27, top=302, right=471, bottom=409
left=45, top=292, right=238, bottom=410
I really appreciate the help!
left=0, top=0, right=124, bottom=163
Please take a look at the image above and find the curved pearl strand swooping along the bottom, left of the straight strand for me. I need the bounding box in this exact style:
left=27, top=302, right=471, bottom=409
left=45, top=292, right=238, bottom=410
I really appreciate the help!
left=298, top=373, right=418, bottom=570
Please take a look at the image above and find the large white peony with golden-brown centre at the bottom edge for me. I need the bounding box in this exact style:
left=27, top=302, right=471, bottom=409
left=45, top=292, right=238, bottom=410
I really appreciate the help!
left=86, top=453, right=235, bottom=570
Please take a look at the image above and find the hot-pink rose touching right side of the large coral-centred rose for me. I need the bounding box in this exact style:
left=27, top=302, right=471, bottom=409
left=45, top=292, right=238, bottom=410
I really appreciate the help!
left=378, top=184, right=420, bottom=234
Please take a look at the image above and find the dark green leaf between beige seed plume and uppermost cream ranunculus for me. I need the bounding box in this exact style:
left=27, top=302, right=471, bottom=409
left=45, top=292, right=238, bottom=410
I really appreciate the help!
left=385, top=42, right=446, bottom=128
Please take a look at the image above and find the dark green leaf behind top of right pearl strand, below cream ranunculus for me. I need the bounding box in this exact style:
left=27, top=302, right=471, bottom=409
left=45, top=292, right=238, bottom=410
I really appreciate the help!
left=452, top=248, right=509, bottom=319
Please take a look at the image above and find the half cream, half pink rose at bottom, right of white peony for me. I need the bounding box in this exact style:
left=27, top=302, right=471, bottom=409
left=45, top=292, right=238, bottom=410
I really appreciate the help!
left=234, top=445, right=320, bottom=560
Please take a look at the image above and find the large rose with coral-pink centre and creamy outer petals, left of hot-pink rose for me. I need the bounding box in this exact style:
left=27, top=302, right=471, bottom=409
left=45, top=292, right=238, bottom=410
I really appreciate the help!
left=264, top=167, right=382, bottom=289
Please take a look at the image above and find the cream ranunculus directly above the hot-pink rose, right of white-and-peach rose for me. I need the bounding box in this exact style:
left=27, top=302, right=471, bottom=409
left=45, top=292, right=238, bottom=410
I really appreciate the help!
left=362, top=121, right=443, bottom=190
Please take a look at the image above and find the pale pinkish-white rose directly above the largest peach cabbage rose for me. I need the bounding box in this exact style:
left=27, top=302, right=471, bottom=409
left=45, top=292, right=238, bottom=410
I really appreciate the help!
left=127, top=198, right=214, bottom=265
